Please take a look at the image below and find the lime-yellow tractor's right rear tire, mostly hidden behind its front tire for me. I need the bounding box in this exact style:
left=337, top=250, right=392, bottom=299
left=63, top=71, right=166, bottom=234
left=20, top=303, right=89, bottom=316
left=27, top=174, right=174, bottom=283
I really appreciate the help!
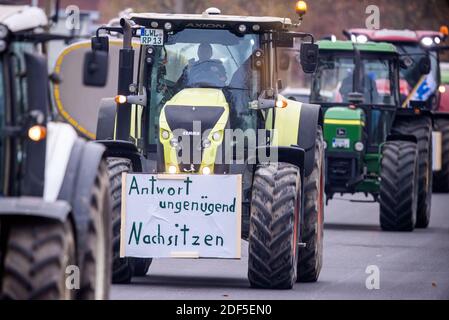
left=297, top=128, right=324, bottom=282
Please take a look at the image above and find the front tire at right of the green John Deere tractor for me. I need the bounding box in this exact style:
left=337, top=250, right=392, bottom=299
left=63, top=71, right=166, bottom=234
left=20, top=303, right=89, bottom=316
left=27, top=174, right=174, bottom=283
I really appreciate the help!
left=379, top=141, right=419, bottom=231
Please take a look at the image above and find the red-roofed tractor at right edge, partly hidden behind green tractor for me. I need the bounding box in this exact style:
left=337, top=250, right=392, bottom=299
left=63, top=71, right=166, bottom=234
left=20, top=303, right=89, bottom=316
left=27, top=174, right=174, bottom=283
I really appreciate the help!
left=343, top=26, right=449, bottom=192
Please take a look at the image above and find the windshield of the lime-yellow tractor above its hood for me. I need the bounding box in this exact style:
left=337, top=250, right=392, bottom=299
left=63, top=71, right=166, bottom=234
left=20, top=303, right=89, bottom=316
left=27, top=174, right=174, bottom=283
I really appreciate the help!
left=143, top=29, right=260, bottom=143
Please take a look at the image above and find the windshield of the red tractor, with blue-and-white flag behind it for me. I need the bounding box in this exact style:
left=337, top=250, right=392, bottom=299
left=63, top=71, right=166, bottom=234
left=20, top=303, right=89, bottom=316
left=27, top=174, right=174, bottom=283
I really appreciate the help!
left=395, top=44, right=438, bottom=101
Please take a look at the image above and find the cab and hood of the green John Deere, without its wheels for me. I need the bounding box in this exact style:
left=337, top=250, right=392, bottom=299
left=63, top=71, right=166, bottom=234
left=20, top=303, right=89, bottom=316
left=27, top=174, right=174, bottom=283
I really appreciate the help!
left=310, top=40, right=399, bottom=196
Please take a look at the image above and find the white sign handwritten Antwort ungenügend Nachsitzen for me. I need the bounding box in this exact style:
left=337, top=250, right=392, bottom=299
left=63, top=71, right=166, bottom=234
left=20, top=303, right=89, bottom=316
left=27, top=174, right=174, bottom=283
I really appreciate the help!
left=120, top=173, right=242, bottom=259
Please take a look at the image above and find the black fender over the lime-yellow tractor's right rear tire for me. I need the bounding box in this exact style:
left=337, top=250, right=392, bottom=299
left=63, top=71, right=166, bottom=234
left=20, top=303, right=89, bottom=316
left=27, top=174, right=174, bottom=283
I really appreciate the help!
left=298, top=103, right=323, bottom=177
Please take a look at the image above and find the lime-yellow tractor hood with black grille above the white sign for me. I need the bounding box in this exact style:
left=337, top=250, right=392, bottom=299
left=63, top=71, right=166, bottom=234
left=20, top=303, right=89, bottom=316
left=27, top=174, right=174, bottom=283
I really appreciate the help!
left=159, top=88, right=229, bottom=173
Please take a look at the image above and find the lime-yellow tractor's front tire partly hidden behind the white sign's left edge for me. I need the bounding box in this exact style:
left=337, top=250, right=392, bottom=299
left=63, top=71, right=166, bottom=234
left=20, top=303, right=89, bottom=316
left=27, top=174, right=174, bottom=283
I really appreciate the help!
left=108, top=158, right=151, bottom=283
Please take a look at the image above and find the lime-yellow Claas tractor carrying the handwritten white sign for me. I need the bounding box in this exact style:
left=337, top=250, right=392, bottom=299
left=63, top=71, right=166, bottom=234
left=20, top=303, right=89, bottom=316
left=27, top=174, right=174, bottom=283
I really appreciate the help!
left=84, top=2, right=324, bottom=288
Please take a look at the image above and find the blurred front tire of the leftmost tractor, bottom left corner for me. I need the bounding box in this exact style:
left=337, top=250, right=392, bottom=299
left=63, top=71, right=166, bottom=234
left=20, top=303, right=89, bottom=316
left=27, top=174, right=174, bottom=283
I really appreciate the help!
left=2, top=218, right=76, bottom=300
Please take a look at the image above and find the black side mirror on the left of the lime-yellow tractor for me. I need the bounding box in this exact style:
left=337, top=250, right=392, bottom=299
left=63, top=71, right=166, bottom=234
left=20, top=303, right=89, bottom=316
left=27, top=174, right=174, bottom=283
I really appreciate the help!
left=83, top=36, right=109, bottom=87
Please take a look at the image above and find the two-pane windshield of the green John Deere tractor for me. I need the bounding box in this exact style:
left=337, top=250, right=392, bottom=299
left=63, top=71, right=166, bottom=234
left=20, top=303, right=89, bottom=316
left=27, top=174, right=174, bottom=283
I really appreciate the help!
left=310, top=55, right=395, bottom=105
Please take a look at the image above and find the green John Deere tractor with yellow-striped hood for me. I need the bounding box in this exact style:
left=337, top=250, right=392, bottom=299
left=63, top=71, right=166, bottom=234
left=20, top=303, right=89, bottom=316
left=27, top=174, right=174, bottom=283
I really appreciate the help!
left=310, top=40, right=432, bottom=231
